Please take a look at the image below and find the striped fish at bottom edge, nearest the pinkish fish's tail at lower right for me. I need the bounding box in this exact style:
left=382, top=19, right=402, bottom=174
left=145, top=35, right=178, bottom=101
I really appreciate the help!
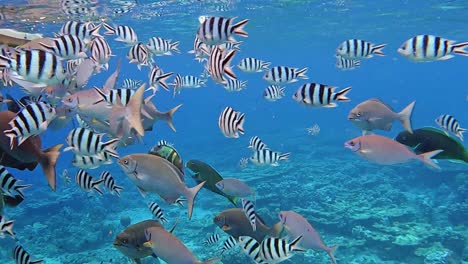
left=260, top=235, right=305, bottom=263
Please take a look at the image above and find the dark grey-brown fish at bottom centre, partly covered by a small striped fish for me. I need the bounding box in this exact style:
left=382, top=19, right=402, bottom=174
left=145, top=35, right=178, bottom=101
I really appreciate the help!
left=213, top=208, right=283, bottom=241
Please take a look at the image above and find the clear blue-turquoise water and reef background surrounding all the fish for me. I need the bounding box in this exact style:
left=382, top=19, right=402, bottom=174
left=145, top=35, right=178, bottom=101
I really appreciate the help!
left=0, top=0, right=468, bottom=264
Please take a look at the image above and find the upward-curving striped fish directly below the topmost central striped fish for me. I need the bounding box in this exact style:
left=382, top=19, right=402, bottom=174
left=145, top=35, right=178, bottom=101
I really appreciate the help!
left=206, top=46, right=237, bottom=84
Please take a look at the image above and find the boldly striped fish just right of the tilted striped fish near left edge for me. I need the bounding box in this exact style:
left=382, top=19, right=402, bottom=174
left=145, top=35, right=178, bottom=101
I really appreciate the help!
left=63, top=127, right=119, bottom=158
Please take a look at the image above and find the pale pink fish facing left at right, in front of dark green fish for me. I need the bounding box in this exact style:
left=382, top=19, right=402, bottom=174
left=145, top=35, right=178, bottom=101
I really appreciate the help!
left=344, top=135, right=443, bottom=169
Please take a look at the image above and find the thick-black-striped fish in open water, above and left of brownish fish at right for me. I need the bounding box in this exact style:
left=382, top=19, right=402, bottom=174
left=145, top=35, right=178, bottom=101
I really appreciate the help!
left=292, top=83, right=351, bottom=107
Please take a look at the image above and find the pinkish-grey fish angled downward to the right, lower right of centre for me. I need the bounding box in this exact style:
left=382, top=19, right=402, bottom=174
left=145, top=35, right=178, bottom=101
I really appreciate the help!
left=279, top=211, right=338, bottom=264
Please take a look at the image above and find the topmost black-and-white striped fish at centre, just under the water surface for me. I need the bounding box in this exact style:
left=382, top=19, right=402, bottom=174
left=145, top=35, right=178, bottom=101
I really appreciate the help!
left=197, top=16, right=249, bottom=45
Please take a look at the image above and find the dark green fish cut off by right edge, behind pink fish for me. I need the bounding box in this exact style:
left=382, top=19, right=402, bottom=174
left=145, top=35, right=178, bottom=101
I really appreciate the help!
left=395, top=127, right=468, bottom=162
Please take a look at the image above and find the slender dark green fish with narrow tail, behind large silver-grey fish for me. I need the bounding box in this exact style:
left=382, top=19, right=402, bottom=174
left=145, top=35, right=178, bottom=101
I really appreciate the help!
left=185, top=160, right=237, bottom=206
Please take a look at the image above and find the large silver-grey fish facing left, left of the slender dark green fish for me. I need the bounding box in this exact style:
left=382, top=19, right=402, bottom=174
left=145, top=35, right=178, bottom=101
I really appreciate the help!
left=118, top=154, right=205, bottom=219
